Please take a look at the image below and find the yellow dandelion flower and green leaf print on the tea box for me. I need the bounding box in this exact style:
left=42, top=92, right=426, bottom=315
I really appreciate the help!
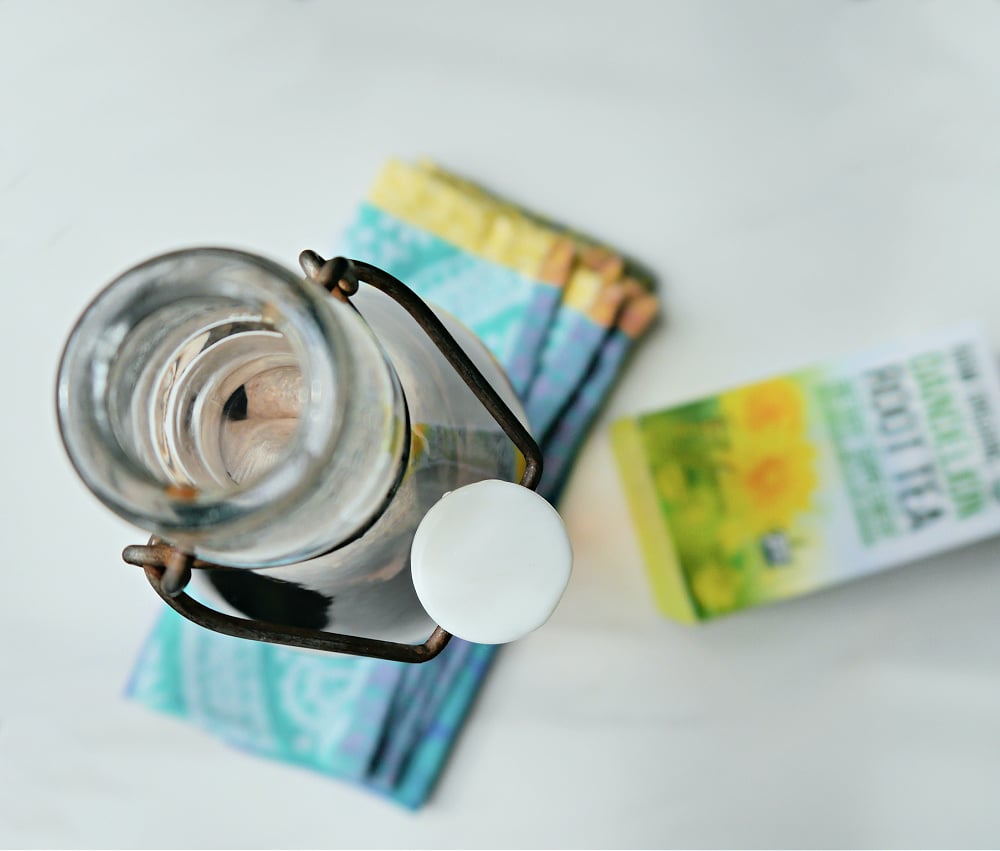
left=620, top=372, right=819, bottom=617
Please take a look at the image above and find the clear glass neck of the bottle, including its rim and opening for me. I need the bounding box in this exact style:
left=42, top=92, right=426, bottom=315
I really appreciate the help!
left=58, top=249, right=409, bottom=566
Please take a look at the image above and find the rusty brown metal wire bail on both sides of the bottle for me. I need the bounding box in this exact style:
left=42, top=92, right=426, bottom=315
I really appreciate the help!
left=122, top=250, right=542, bottom=662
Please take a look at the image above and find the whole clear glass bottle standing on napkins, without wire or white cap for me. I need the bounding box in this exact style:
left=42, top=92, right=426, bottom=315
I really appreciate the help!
left=58, top=248, right=524, bottom=643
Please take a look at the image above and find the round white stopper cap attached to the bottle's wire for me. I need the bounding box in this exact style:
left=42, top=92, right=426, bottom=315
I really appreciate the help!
left=410, top=479, right=573, bottom=644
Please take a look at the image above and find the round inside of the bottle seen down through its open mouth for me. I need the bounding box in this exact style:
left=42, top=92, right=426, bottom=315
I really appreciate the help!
left=107, top=298, right=306, bottom=497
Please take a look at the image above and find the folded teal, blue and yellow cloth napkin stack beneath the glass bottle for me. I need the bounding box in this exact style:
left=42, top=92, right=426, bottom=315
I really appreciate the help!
left=127, top=161, right=656, bottom=808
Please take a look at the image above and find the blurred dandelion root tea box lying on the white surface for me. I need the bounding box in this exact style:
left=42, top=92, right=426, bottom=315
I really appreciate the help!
left=612, top=327, right=1000, bottom=623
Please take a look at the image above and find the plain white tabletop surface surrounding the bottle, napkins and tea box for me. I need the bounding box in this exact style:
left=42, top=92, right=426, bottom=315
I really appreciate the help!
left=0, top=0, right=1000, bottom=848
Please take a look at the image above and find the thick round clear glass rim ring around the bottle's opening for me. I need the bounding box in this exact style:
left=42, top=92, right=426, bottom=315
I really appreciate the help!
left=56, top=247, right=349, bottom=532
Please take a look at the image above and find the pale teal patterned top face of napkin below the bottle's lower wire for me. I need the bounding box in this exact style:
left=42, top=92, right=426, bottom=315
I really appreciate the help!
left=128, top=609, right=405, bottom=780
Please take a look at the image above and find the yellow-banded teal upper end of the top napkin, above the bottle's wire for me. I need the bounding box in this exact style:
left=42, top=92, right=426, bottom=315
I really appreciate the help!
left=356, top=160, right=573, bottom=396
